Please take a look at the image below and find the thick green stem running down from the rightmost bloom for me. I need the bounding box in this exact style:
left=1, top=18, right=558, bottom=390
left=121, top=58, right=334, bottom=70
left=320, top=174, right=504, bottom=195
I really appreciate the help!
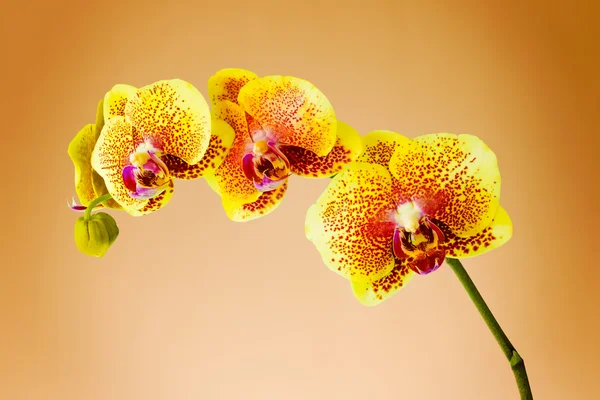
left=446, top=258, right=533, bottom=400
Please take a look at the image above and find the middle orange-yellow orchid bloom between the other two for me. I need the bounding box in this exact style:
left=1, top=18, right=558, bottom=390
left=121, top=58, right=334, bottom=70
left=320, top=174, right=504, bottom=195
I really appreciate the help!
left=205, top=68, right=362, bottom=221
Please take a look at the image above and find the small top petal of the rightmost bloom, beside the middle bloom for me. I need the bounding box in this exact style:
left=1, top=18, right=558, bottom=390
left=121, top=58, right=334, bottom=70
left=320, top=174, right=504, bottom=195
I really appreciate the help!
left=356, top=130, right=410, bottom=168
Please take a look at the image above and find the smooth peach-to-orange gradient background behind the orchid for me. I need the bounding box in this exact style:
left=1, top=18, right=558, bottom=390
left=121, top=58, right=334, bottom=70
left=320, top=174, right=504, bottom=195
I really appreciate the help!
left=0, top=0, right=600, bottom=400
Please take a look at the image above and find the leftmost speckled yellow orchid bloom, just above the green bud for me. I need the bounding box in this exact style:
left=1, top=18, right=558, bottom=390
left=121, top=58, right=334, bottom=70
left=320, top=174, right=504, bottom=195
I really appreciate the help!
left=69, top=79, right=234, bottom=216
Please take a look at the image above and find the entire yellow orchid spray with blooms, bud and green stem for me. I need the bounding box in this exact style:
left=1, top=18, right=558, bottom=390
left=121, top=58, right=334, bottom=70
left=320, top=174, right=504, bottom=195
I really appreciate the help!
left=68, top=68, right=533, bottom=400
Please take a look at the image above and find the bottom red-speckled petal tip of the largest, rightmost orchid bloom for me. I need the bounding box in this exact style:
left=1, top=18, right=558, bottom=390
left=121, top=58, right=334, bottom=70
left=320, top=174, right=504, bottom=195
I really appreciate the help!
left=351, top=260, right=415, bottom=306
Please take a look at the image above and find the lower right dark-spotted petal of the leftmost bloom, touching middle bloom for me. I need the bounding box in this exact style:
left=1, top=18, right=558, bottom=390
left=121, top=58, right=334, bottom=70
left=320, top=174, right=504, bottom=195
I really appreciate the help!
left=161, top=119, right=235, bottom=179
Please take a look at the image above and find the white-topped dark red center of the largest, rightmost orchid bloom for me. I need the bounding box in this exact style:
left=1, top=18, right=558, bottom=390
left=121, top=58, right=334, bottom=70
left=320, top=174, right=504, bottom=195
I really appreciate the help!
left=393, top=202, right=446, bottom=275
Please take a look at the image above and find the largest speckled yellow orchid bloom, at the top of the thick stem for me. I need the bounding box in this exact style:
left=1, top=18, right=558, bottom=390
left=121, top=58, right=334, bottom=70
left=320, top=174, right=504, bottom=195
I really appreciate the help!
left=306, top=131, right=512, bottom=305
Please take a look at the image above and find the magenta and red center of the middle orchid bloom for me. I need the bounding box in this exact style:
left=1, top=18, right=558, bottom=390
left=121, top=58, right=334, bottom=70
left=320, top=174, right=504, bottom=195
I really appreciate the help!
left=242, top=139, right=291, bottom=192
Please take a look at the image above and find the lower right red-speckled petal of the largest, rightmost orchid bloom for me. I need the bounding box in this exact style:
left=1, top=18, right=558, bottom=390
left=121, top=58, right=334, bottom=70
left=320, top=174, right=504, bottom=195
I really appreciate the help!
left=441, top=207, right=512, bottom=258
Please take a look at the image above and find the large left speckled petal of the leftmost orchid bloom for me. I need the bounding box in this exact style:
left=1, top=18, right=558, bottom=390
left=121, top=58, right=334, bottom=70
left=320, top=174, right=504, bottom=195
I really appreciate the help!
left=92, top=117, right=147, bottom=214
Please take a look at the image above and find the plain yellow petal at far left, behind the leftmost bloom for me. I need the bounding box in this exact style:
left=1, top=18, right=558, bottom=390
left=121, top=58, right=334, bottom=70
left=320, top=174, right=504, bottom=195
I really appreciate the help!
left=68, top=124, right=97, bottom=206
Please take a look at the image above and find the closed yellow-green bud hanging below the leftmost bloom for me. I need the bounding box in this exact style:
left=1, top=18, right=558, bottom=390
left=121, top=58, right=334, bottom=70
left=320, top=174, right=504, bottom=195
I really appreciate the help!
left=75, top=212, right=119, bottom=257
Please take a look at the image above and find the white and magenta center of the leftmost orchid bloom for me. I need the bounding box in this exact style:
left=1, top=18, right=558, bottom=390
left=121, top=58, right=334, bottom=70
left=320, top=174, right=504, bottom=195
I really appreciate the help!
left=123, top=143, right=171, bottom=200
